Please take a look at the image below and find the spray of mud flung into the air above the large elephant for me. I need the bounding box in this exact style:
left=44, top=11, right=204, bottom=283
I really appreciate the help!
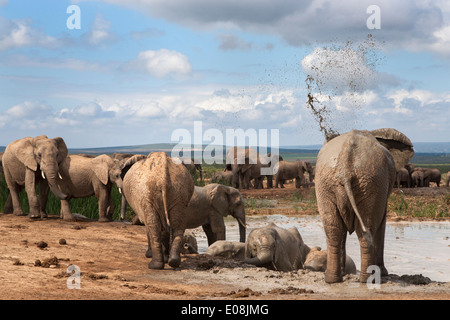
left=302, top=34, right=383, bottom=141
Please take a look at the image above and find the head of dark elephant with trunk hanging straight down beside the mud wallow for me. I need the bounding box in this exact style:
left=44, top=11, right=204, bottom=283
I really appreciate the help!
left=210, top=185, right=246, bottom=242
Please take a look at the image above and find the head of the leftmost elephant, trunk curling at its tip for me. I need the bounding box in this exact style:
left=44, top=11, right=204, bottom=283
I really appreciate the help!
left=19, top=135, right=69, bottom=200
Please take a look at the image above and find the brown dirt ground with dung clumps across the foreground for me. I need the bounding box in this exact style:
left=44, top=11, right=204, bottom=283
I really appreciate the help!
left=0, top=187, right=450, bottom=300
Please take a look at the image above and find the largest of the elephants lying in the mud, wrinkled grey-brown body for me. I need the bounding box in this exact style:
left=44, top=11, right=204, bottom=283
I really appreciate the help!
left=244, top=222, right=310, bottom=271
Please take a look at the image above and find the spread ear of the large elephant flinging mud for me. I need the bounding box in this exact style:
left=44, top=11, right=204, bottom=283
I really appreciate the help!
left=370, top=128, right=414, bottom=171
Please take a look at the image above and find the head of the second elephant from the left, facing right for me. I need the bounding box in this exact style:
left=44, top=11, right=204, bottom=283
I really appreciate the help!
left=92, top=154, right=123, bottom=192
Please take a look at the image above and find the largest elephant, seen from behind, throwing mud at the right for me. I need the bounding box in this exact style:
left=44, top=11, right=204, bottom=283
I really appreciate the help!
left=315, top=128, right=414, bottom=283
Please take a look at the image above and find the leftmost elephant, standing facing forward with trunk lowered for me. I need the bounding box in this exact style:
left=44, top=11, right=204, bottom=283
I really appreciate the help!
left=2, top=135, right=68, bottom=218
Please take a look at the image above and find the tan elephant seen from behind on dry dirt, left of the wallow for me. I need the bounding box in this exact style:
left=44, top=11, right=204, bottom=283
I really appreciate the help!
left=123, top=152, right=194, bottom=269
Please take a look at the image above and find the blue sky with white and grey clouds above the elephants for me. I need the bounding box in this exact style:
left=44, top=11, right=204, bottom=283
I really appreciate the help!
left=0, top=0, right=450, bottom=148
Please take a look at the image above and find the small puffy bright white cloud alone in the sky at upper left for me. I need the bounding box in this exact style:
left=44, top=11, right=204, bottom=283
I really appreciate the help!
left=124, top=49, right=192, bottom=78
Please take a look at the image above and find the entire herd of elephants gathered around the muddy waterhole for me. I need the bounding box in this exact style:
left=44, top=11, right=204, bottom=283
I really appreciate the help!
left=0, top=128, right=446, bottom=283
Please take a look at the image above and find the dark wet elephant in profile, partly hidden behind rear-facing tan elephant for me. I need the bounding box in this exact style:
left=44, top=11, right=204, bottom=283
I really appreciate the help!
left=184, top=183, right=245, bottom=245
